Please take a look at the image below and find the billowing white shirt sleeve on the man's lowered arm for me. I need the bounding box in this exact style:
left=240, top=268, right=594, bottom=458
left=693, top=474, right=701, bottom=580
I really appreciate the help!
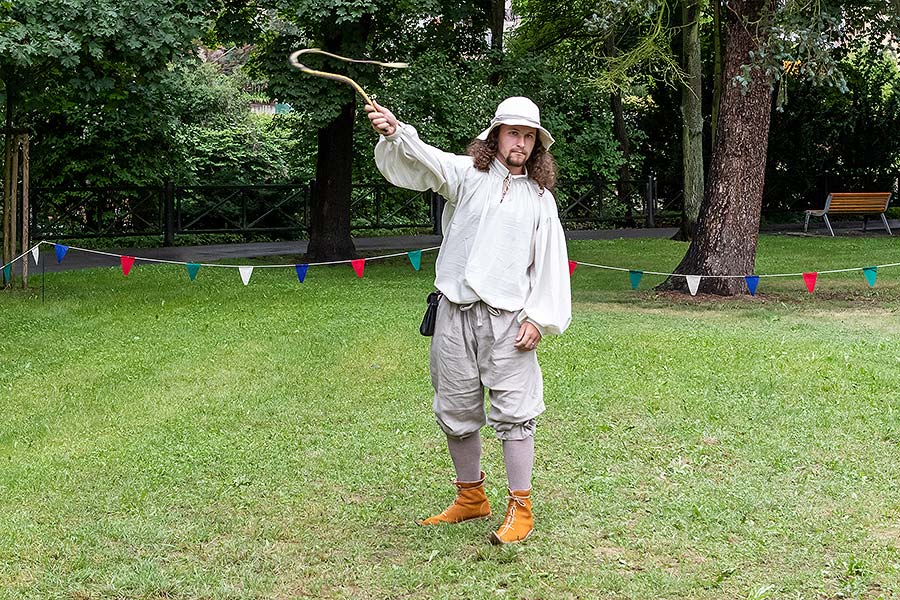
left=519, top=196, right=572, bottom=335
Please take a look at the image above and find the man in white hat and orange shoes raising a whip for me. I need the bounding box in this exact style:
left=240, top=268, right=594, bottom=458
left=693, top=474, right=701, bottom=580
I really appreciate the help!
left=366, top=97, right=572, bottom=544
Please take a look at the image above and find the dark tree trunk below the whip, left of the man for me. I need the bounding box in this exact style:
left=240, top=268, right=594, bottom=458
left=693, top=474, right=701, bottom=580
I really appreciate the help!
left=306, top=96, right=356, bottom=262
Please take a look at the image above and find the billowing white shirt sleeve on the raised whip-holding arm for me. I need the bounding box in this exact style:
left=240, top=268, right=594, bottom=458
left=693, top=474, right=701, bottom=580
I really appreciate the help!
left=375, top=123, right=472, bottom=204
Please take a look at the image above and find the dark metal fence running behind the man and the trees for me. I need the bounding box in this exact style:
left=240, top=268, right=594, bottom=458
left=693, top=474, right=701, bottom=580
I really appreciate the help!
left=30, top=177, right=662, bottom=244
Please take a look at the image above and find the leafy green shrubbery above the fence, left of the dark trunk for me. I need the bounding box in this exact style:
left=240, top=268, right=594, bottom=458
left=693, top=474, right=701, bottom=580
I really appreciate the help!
left=32, top=59, right=312, bottom=186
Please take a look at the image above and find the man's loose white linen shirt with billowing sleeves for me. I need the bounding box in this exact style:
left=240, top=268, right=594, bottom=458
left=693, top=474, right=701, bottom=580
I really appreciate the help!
left=375, top=123, right=572, bottom=335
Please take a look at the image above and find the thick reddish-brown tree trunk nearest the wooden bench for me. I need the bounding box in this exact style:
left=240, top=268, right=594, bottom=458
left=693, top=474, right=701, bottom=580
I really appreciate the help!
left=660, top=0, right=774, bottom=295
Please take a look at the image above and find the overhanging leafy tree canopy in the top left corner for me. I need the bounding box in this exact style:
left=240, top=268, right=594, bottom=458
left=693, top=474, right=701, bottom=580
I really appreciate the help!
left=0, top=0, right=205, bottom=110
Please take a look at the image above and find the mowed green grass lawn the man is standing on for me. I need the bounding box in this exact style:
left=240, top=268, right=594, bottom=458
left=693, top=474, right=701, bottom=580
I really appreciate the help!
left=0, top=236, right=900, bottom=599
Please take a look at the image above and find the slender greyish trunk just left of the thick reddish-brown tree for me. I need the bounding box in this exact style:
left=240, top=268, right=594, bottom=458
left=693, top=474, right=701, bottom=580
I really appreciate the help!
left=681, top=0, right=703, bottom=240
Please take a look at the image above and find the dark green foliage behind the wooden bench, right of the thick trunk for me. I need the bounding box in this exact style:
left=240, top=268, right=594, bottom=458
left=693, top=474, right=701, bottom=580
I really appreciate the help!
left=766, top=46, right=900, bottom=210
